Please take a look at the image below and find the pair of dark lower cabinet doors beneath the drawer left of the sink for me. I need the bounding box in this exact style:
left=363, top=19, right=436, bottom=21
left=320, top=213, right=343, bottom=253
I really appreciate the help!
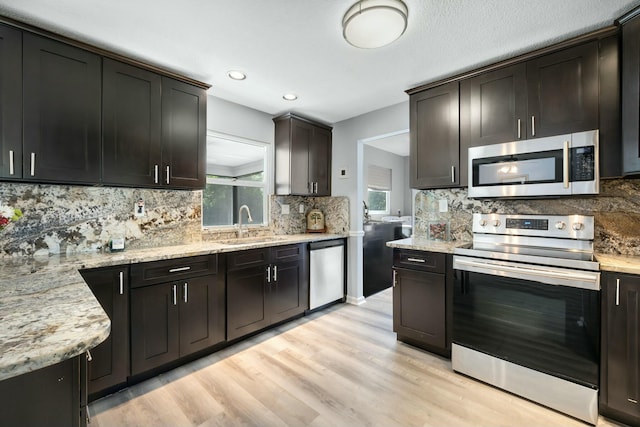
left=131, top=274, right=225, bottom=375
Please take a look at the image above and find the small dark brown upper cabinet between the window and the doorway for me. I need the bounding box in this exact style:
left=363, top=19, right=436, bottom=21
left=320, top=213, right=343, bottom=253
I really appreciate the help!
left=273, top=114, right=331, bottom=196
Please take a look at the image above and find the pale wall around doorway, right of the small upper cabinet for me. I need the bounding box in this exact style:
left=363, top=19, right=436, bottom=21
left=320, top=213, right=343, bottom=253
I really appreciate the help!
left=331, top=100, right=409, bottom=304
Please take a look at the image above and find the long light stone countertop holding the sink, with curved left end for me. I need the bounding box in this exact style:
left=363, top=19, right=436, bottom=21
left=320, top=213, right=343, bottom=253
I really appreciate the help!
left=0, top=233, right=347, bottom=381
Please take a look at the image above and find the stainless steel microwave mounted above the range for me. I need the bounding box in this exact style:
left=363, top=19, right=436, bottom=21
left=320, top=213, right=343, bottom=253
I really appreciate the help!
left=469, top=130, right=600, bottom=198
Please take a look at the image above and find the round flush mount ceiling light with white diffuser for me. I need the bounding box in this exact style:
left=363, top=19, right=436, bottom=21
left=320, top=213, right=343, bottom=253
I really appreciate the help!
left=342, top=0, right=409, bottom=49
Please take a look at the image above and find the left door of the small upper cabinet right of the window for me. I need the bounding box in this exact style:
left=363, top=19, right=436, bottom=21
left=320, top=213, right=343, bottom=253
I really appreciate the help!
left=290, top=119, right=314, bottom=196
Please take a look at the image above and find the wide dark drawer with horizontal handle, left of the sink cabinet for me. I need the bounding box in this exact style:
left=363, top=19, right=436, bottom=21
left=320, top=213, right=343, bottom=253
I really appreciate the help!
left=131, top=255, right=218, bottom=288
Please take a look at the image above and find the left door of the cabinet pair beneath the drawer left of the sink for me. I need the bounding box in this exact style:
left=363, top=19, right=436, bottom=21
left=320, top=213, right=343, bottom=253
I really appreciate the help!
left=131, top=284, right=180, bottom=375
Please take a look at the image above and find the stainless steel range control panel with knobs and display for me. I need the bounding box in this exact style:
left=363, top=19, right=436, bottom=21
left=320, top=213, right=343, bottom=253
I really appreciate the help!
left=473, top=213, right=594, bottom=240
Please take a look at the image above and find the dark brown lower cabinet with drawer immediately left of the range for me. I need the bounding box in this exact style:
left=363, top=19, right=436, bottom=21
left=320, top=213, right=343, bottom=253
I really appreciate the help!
left=393, top=249, right=452, bottom=357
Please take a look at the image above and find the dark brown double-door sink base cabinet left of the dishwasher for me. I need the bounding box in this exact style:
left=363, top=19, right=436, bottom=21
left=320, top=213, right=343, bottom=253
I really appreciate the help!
left=227, top=244, right=309, bottom=340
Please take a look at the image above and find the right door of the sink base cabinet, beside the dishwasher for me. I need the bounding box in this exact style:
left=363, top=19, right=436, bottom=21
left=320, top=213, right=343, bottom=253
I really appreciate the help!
left=267, top=261, right=309, bottom=323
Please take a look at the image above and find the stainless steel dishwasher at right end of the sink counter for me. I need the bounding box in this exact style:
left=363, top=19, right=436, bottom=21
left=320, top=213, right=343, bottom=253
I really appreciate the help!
left=309, top=239, right=346, bottom=310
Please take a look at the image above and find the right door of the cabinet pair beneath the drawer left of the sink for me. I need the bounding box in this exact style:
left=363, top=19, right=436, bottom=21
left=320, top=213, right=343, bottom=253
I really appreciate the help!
left=179, top=275, right=226, bottom=357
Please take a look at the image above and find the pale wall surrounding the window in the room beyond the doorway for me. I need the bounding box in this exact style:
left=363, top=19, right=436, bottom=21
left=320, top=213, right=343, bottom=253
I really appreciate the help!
left=361, top=145, right=411, bottom=219
